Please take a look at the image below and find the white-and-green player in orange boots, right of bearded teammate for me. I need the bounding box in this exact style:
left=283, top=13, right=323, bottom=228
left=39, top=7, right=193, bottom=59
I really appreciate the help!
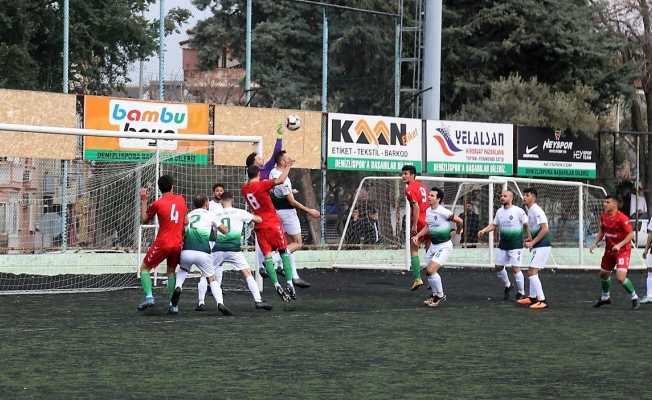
left=517, top=188, right=552, bottom=310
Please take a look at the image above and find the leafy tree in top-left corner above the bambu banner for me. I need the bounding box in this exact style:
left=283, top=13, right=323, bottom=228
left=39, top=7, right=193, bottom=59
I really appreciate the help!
left=0, top=0, right=190, bottom=94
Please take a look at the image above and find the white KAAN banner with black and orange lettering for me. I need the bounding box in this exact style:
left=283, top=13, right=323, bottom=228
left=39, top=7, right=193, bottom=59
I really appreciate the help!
left=327, top=113, right=423, bottom=172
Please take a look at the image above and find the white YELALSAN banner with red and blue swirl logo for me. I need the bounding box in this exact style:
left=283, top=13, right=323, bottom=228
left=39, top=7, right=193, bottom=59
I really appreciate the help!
left=426, top=121, right=514, bottom=175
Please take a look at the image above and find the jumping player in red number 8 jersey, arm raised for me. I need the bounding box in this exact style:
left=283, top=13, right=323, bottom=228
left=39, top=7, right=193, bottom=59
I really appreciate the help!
left=242, top=163, right=296, bottom=301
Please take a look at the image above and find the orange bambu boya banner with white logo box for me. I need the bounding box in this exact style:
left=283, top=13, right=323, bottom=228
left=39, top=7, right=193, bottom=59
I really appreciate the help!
left=84, top=96, right=208, bottom=164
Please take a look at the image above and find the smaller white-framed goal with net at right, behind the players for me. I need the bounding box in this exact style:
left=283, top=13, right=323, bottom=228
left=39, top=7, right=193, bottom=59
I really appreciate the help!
left=333, top=177, right=642, bottom=270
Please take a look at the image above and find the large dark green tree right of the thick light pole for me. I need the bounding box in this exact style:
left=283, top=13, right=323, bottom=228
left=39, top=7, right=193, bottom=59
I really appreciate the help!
left=442, top=0, right=631, bottom=114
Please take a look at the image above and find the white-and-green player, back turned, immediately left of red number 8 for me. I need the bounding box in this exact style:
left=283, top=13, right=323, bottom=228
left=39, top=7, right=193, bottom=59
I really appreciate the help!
left=197, top=192, right=272, bottom=310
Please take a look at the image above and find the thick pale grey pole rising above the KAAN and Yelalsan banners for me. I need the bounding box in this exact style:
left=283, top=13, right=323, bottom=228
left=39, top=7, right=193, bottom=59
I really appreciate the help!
left=421, top=0, right=443, bottom=120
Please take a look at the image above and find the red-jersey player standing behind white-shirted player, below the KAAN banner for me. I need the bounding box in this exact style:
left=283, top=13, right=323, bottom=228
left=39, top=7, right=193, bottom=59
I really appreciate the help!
left=401, top=165, right=430, bottom=290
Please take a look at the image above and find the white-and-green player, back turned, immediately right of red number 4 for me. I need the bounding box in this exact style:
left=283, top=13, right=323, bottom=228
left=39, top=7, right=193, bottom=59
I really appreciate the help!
left=169, top=194, right=231, bottom=315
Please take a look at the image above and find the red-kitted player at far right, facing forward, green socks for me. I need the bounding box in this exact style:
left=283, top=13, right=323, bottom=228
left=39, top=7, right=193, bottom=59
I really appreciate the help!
left=590, top=196, right=639, bottom=310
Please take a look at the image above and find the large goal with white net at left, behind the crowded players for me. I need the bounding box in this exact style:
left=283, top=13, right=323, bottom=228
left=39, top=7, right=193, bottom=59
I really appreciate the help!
left=0, top=125, right=261, bottom=294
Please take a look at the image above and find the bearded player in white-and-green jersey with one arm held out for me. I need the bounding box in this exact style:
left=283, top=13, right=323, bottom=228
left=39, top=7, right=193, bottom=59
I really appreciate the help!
left=478, top=189, right=527, bottom=300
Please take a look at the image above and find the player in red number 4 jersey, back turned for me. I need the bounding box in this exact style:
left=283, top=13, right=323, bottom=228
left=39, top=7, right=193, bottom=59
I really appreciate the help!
left=138, top=175, right=188, bottom=311
